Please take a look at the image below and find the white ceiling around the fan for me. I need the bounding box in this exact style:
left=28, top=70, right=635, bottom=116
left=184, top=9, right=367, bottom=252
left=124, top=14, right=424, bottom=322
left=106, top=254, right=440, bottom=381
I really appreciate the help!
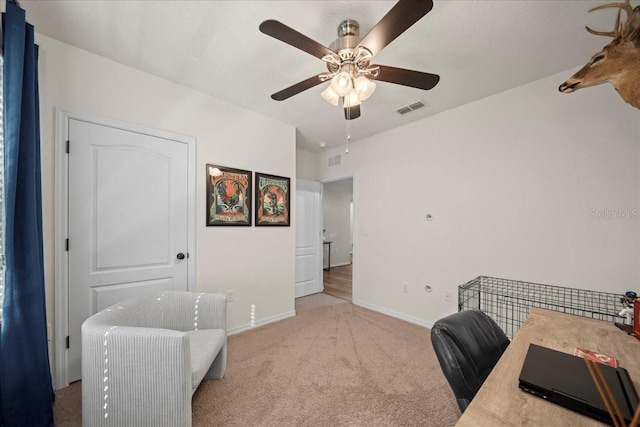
left=20, top=0, right=615, bottom=152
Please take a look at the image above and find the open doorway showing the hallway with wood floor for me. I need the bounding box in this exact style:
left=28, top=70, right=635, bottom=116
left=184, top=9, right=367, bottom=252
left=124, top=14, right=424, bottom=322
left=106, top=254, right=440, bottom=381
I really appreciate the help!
left=322, top=177, right=354, bottom=301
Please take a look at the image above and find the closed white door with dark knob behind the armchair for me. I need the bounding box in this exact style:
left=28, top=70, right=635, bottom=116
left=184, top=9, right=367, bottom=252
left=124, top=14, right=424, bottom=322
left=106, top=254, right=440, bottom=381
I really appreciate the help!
left=67, top=119, right=190, bottom=382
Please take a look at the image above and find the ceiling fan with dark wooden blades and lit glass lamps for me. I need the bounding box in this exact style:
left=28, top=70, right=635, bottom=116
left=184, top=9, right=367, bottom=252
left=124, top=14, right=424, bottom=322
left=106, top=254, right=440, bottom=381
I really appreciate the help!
left=259, top=0, right=440, bottom=120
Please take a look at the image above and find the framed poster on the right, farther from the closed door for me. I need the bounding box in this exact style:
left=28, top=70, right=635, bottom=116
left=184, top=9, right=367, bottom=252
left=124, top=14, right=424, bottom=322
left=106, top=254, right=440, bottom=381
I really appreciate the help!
left=255, top=172, right=291, bottom=227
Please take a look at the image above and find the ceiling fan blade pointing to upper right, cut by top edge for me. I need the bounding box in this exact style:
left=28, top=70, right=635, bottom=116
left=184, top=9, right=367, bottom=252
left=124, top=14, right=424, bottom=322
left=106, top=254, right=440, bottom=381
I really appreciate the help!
left=358, top=0, right=433, bottom=56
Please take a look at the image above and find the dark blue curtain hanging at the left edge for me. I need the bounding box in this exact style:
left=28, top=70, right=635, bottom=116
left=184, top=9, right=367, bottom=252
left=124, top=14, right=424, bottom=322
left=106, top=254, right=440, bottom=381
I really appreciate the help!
left=0, top=1, right=54, bottom=427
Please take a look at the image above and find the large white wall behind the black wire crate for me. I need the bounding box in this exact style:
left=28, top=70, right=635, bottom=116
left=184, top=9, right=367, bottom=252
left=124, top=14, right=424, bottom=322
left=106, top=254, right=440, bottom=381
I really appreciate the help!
left=318, top=70, right=640, bottom=325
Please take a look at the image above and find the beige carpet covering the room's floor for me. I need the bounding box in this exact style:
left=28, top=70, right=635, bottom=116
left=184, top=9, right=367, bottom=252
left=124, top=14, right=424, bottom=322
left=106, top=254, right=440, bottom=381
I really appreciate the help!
left=54, top=294, right=460, bottom=427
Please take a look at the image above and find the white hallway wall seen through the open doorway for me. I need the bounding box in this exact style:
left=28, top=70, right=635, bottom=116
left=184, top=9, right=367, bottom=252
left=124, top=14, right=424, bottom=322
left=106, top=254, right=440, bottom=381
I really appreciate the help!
left=322, top=178, right=353, bottom=267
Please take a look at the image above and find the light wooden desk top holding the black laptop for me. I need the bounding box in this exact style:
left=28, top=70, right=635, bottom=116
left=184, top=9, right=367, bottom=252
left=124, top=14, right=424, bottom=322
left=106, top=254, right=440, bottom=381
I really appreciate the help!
left=456, top=308, right=640, bottom=427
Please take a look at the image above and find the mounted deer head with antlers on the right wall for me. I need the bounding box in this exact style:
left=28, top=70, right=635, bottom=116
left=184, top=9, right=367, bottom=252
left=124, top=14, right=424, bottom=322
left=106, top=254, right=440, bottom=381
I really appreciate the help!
left=558, top=0, right=640, bottom=109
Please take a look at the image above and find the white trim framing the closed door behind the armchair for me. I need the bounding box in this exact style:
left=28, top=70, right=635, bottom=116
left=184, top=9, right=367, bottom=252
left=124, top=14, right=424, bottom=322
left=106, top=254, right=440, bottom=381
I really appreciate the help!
left=53, top=107, right=196, bottom=389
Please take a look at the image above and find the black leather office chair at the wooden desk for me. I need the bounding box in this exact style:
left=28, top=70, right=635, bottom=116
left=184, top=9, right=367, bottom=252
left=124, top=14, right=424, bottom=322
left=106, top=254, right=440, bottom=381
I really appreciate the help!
left=431, top=310, right=509, bottom=412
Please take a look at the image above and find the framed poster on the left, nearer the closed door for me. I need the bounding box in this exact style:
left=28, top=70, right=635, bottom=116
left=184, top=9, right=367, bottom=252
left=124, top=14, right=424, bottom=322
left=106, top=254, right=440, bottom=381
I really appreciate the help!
left=207, top=164, right=251, bottom=226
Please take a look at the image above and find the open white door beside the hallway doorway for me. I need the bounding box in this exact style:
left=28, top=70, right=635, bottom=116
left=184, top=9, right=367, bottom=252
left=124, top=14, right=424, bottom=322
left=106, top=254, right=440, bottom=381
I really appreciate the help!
left=295, top=179, right=323, bottom=298
